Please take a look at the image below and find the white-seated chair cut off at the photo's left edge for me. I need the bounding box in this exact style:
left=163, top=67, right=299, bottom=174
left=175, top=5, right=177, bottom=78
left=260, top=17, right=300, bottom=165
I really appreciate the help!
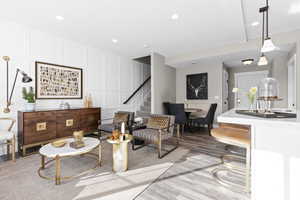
left=0, top=118, right=16, bottom=162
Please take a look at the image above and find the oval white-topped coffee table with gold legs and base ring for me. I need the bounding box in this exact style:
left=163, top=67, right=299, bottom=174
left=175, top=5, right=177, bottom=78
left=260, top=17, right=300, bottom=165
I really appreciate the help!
left=38, top=137, right=101, bottom=185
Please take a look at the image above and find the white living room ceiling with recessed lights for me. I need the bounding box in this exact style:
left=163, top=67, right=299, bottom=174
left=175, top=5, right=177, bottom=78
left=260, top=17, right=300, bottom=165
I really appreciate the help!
left=0, top=0, right=300, bottom=57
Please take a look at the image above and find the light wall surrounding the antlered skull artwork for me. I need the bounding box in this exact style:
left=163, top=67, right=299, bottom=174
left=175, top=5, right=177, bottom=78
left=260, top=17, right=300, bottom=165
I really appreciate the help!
left=176, top=61, right=223, bottom=116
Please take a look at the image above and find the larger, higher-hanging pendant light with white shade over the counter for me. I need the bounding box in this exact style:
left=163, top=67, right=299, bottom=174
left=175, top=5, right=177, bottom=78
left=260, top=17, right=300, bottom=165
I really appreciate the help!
left=259, top=0, right=279, bottom=53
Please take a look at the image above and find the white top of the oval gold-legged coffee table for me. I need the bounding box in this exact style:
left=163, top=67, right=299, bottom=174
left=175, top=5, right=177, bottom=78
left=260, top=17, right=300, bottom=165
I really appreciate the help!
left=39, top=137, right=100, bottom=158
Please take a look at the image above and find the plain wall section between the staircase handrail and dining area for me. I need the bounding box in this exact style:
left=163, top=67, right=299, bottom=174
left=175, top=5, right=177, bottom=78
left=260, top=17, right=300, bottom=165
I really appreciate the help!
left=151, top=53, right=176, bottom=114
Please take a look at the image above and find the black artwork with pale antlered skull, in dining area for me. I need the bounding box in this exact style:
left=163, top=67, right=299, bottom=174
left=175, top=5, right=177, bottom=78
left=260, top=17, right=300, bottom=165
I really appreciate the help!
left=186, top=73, right=208, bottom=99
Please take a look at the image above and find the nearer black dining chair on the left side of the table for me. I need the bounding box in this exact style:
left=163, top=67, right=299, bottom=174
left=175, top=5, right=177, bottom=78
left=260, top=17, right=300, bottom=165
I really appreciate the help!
left=169, top=103, right=187, bottom=134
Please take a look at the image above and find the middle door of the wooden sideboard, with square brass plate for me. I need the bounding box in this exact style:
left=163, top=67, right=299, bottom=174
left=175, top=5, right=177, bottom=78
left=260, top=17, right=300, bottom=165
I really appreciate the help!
left=56, top=110, right=80, bottom=138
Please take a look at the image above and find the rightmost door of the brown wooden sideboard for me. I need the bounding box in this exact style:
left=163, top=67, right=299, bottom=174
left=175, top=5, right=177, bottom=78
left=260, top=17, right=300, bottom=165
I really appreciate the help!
left=80, top=108, right=100, bottom=133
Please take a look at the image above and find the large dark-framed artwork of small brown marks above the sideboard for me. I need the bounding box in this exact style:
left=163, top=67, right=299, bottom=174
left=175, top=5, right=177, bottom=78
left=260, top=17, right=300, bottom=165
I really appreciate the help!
left=35, top=62, right=83, bottom=99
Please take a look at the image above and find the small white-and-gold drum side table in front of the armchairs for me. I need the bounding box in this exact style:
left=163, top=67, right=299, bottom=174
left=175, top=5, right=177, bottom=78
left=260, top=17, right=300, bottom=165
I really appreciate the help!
left=107, top=135, right=132, bottom=172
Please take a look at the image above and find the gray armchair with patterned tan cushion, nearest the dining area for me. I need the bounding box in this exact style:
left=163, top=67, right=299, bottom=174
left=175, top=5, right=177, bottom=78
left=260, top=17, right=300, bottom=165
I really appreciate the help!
left=132, top=115, right=179, bottom=158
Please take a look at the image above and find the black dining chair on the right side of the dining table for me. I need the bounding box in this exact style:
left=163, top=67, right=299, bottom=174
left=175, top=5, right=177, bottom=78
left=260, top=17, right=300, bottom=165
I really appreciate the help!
left=190, top=103, right=218, bottom=134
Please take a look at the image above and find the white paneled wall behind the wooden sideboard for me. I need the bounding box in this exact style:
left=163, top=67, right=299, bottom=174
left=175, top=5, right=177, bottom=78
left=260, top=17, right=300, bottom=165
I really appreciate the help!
left=0, top=21, right=150, bottom=153
